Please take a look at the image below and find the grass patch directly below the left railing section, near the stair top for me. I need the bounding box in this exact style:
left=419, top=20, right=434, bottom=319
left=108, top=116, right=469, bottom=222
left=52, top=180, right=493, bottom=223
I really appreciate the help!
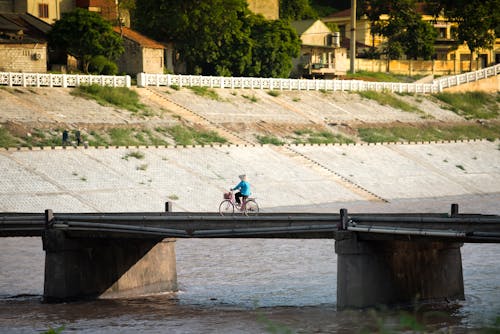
left=71, top=85, right=147, bottom=113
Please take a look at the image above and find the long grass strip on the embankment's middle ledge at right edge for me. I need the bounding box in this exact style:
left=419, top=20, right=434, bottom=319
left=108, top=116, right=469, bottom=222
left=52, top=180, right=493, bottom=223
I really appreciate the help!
left=358, top=124, right=500, bottom=143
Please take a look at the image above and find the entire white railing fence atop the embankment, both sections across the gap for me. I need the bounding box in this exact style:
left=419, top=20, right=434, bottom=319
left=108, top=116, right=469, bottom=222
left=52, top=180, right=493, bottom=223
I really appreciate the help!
left=0, top=64, right=500, bottom=90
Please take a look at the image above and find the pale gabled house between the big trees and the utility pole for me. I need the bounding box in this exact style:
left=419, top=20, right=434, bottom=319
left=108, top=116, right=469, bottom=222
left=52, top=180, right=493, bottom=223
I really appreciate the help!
left=292, top=20, right=349, bottom=78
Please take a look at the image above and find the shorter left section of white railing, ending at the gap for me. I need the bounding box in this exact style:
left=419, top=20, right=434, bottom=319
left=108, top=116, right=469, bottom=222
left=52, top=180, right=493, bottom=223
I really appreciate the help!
left=0, top=72, right=131, bottom=87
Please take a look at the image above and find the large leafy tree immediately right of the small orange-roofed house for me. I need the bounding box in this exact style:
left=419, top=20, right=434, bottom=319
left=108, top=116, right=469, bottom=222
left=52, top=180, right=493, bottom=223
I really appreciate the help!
left=134, top=0, right=251, bottom=75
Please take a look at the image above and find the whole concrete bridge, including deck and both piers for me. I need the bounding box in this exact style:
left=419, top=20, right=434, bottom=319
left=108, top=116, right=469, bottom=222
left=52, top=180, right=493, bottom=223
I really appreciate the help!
left=0, top=204, right=500, bottom=309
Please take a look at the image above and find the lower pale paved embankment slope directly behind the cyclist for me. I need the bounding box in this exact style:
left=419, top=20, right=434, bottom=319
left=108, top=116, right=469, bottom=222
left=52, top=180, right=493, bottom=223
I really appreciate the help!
left=0, top=141, right=500, bottom=214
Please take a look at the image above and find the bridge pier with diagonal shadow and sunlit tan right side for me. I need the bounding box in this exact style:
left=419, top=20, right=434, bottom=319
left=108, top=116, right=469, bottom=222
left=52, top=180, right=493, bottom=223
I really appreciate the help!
left=43, top=229, right=177, bottom=302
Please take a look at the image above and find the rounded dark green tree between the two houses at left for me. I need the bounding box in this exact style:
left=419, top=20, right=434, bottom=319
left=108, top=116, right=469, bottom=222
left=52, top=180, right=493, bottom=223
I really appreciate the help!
left=48, top=8, right=124, bottom=73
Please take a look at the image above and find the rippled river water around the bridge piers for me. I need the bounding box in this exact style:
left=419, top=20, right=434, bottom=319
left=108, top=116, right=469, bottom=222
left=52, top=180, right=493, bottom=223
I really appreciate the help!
left=0, top=238, right=500, bottom=333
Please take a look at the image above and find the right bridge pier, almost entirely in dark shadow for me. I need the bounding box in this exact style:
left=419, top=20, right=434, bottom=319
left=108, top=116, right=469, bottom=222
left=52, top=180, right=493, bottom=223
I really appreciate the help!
left=335, top=232, right=465, bottom=309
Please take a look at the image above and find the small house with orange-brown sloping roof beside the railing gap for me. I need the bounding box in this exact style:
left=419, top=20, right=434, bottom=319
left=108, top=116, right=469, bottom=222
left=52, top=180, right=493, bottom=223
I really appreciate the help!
left=113, top=27, right=165, bottom=74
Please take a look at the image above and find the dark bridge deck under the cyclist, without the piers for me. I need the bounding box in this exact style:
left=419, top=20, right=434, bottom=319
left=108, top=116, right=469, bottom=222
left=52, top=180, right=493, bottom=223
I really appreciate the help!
left=0, top=210, right=500, bottom=243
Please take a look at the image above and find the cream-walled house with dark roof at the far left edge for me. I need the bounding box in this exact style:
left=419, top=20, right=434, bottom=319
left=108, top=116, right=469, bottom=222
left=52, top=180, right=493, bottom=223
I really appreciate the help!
left=0, top=13, right=51, bottom=73
